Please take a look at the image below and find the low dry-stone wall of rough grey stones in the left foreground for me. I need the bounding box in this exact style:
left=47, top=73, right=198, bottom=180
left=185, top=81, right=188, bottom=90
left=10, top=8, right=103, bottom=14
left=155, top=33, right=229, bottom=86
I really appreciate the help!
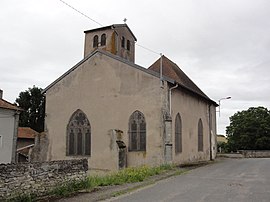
left=0, top=159, right=88, bottom=201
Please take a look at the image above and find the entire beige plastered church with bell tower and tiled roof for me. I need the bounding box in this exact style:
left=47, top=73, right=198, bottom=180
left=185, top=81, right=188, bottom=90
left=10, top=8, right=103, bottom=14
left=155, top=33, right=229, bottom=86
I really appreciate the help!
left=43, top=24, right=217, bottom=170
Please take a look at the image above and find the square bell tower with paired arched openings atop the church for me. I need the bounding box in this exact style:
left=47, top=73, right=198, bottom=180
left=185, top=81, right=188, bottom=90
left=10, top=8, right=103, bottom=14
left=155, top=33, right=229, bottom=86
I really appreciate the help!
left=84, top=24, right=137, bottom=63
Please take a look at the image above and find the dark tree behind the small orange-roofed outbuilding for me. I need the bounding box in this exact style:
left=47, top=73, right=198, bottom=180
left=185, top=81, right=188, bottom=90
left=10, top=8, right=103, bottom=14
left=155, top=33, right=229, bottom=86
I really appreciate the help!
left=16, top=86, right=45, bottom=132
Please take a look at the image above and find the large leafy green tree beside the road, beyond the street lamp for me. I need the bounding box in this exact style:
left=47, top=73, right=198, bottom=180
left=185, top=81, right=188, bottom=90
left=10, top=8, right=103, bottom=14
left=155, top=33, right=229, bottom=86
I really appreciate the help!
left=226, top=107, right=270, bottom=151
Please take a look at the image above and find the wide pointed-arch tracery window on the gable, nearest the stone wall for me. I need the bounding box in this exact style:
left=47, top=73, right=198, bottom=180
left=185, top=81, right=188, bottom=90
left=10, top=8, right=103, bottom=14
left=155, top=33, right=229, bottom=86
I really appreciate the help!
left=67, top=109, right=91, bottom=156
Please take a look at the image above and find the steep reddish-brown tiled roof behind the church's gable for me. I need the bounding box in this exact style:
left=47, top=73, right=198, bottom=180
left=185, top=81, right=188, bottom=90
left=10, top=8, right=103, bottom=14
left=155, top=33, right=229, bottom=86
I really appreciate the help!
left=148, top=55, right=214, bottom=100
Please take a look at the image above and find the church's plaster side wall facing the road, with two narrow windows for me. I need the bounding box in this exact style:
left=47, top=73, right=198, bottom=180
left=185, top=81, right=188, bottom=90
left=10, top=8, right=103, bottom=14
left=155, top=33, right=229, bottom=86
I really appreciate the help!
left=172, top=89, right=215, bottom=163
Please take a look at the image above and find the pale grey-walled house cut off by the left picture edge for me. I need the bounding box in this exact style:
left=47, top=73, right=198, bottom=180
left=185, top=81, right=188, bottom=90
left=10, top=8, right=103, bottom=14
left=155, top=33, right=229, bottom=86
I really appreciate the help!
left=0, top=90, right=21, bottom=163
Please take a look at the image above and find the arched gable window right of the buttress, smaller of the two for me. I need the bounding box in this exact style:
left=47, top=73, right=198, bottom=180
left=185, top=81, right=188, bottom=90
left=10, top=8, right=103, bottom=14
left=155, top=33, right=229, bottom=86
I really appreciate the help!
left=128, top=111, right=146, bottom=151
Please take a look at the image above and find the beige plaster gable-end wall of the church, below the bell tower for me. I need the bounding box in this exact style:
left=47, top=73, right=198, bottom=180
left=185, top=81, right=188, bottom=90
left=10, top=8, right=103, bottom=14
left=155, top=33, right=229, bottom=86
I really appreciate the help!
left=46, top=53, right=166, bottom=170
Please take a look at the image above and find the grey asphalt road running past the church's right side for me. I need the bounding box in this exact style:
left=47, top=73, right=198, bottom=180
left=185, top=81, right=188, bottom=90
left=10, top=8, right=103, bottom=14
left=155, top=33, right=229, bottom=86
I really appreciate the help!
left=106, top=158, right=270, bottom=202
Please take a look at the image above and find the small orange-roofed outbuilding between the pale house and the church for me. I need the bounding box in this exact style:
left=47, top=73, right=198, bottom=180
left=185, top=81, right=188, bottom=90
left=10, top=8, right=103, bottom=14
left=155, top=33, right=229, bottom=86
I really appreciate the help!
left=17, top=127, right=38, bottom=162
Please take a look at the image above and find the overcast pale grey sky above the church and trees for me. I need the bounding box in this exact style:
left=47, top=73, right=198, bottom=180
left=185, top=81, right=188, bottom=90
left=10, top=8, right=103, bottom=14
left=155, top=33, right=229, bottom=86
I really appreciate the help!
left=0, top=0, right=270, bottom=134
